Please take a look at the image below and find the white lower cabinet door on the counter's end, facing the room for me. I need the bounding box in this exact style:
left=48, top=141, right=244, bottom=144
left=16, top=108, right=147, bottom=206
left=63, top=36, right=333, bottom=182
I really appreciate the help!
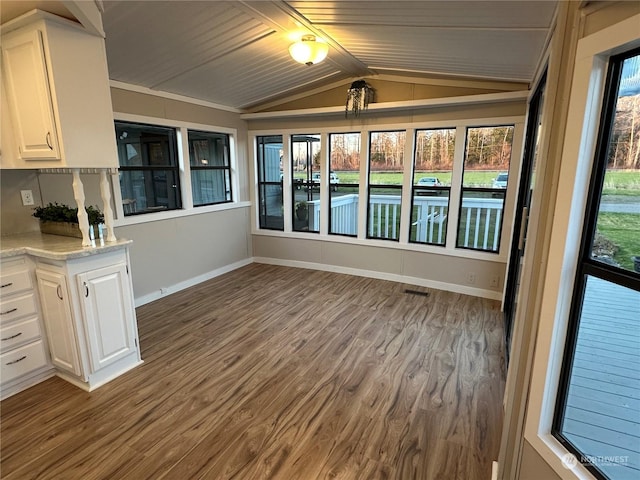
left=78, top=264, right=137, bottom=372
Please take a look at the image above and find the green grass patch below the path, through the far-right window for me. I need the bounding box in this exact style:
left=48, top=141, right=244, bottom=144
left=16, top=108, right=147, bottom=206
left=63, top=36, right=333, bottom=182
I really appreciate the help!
left=598, top=212, right=640, bottom=270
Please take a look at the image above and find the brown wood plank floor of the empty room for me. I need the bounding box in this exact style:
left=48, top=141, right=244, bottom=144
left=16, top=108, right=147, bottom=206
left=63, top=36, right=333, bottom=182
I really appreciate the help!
left=0, top=264, right=504, bottom=480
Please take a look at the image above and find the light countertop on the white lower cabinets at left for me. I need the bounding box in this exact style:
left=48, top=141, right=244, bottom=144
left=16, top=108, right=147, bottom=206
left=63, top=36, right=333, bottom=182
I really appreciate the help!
left=0, top=232, right=133, bottom=260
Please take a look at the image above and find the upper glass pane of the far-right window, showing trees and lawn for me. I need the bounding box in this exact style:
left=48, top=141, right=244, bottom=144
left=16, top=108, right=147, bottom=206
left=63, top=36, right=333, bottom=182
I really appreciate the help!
left=591, top=56, right=640, bottom=271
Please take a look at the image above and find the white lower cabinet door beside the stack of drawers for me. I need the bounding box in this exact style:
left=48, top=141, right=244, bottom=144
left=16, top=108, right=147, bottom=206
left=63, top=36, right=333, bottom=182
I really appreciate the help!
left=36, top=270, right=82, bottom=376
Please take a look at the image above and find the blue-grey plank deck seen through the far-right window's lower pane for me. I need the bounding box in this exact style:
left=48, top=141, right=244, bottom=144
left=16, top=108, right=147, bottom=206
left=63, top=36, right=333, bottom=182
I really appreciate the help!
left=563, top=277, right=640, bottom=480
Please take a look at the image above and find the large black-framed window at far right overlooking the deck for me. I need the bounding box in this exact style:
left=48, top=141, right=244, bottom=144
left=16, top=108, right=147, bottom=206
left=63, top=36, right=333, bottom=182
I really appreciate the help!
left=552, top=49, right=640, bottom=480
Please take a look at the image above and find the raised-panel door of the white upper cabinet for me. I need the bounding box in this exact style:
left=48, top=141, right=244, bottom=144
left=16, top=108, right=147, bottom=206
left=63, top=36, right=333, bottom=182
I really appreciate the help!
left=2, top=30, right=60, bottom=160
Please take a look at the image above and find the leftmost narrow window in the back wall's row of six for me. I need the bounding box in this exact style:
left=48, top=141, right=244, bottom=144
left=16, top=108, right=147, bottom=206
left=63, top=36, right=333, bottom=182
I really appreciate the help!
left=256, top=135, right=284, bottom=230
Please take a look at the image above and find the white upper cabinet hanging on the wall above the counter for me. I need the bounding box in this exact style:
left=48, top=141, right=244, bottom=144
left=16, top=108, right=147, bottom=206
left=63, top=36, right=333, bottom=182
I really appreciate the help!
left=2, top=11, right=118, bottom=168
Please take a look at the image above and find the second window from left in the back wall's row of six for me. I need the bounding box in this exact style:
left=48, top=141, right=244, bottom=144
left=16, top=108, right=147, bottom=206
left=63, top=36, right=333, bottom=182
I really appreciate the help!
left=291, top=135, right=320, bottom=233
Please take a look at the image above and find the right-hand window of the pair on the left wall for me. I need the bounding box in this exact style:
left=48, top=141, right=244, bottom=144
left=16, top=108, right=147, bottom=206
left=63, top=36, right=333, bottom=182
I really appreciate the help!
left=188, top=130, right=232, bottom=206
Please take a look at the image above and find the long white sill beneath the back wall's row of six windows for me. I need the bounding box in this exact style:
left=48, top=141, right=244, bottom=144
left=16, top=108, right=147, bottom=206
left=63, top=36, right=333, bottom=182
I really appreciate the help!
left=251, top=228, right=507, bottom=263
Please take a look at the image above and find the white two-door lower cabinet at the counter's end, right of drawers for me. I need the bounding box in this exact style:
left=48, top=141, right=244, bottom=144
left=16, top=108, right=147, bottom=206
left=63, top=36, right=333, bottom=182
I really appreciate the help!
left=36, top=250, right=141, bottom=390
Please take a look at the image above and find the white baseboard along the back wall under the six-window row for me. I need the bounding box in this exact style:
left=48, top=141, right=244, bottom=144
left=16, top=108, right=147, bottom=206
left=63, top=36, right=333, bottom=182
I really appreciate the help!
left=253, top=257, right=502, bottom=300
